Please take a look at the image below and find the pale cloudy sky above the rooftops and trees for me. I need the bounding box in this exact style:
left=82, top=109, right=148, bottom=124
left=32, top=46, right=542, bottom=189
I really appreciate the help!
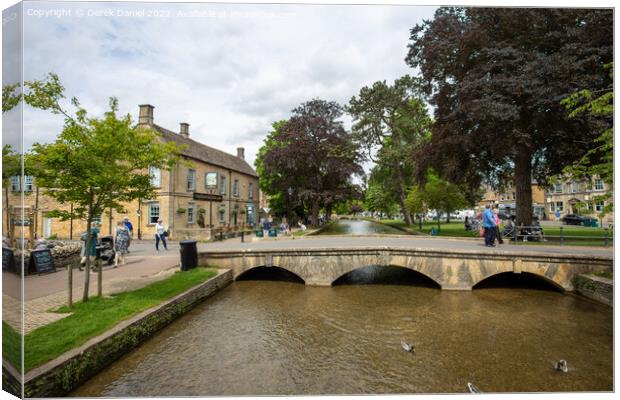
left=3, top=2, right=436, bottom=164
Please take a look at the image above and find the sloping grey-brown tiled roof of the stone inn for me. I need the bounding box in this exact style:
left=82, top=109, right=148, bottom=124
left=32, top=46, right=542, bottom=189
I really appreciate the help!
left=152, top=124, right=258, bottom=178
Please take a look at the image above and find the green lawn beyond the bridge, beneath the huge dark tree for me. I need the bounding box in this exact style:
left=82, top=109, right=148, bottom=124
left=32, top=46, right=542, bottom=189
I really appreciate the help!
left=370, top=219, right=613, bottom=246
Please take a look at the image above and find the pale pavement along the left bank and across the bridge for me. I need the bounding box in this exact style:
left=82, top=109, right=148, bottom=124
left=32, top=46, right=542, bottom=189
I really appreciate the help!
left=2, top=235, right=613, bottom=333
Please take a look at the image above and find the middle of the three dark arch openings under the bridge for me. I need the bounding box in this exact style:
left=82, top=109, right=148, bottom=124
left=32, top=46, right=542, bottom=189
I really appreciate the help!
left=331, top=264, right=441, bottom=289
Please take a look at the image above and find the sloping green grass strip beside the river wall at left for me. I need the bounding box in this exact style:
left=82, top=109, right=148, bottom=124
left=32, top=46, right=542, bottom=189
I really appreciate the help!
left=24, top=268, right=217, bottom=372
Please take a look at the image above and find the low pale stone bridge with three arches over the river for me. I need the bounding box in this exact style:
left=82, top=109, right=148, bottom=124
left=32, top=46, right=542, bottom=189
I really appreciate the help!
left=199, top=246, right=613, bottom=291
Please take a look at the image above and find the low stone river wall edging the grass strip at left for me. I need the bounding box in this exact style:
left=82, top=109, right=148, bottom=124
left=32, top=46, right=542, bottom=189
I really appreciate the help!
left=24, top=270, right=232, bottom=397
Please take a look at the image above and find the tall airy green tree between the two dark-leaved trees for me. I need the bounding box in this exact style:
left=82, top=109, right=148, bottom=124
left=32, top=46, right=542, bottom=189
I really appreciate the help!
left=347, top=75, right=431, bottom=225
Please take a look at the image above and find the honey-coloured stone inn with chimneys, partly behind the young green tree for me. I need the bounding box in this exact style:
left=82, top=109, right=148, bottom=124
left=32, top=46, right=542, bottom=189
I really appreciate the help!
left=2, top=104, right=259, bottom=240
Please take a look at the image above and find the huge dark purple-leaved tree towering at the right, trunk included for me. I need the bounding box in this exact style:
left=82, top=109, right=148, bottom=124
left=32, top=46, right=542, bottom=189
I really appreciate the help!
left=406, top=8, right=613, bottom=224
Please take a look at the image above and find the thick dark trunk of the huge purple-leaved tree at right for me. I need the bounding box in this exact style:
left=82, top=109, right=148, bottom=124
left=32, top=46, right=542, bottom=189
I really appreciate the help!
left=514, top=144, right=532, bottom=226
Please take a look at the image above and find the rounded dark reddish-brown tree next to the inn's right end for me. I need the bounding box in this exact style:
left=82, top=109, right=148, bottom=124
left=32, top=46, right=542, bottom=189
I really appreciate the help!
left=256, top=99, right=363, bottom=225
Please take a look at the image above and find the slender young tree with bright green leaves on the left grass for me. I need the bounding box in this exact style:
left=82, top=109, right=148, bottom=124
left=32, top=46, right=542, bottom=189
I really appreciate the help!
left=25, top=74, right=180, bottom=301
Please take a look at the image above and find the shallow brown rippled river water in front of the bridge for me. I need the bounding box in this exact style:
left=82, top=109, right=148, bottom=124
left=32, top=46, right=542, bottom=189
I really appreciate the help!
left=72, top=281, right=613, bottom=397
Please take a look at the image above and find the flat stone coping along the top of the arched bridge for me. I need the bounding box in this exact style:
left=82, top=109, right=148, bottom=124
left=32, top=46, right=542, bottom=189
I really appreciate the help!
left=198, top=246, right=613, bottom=262
